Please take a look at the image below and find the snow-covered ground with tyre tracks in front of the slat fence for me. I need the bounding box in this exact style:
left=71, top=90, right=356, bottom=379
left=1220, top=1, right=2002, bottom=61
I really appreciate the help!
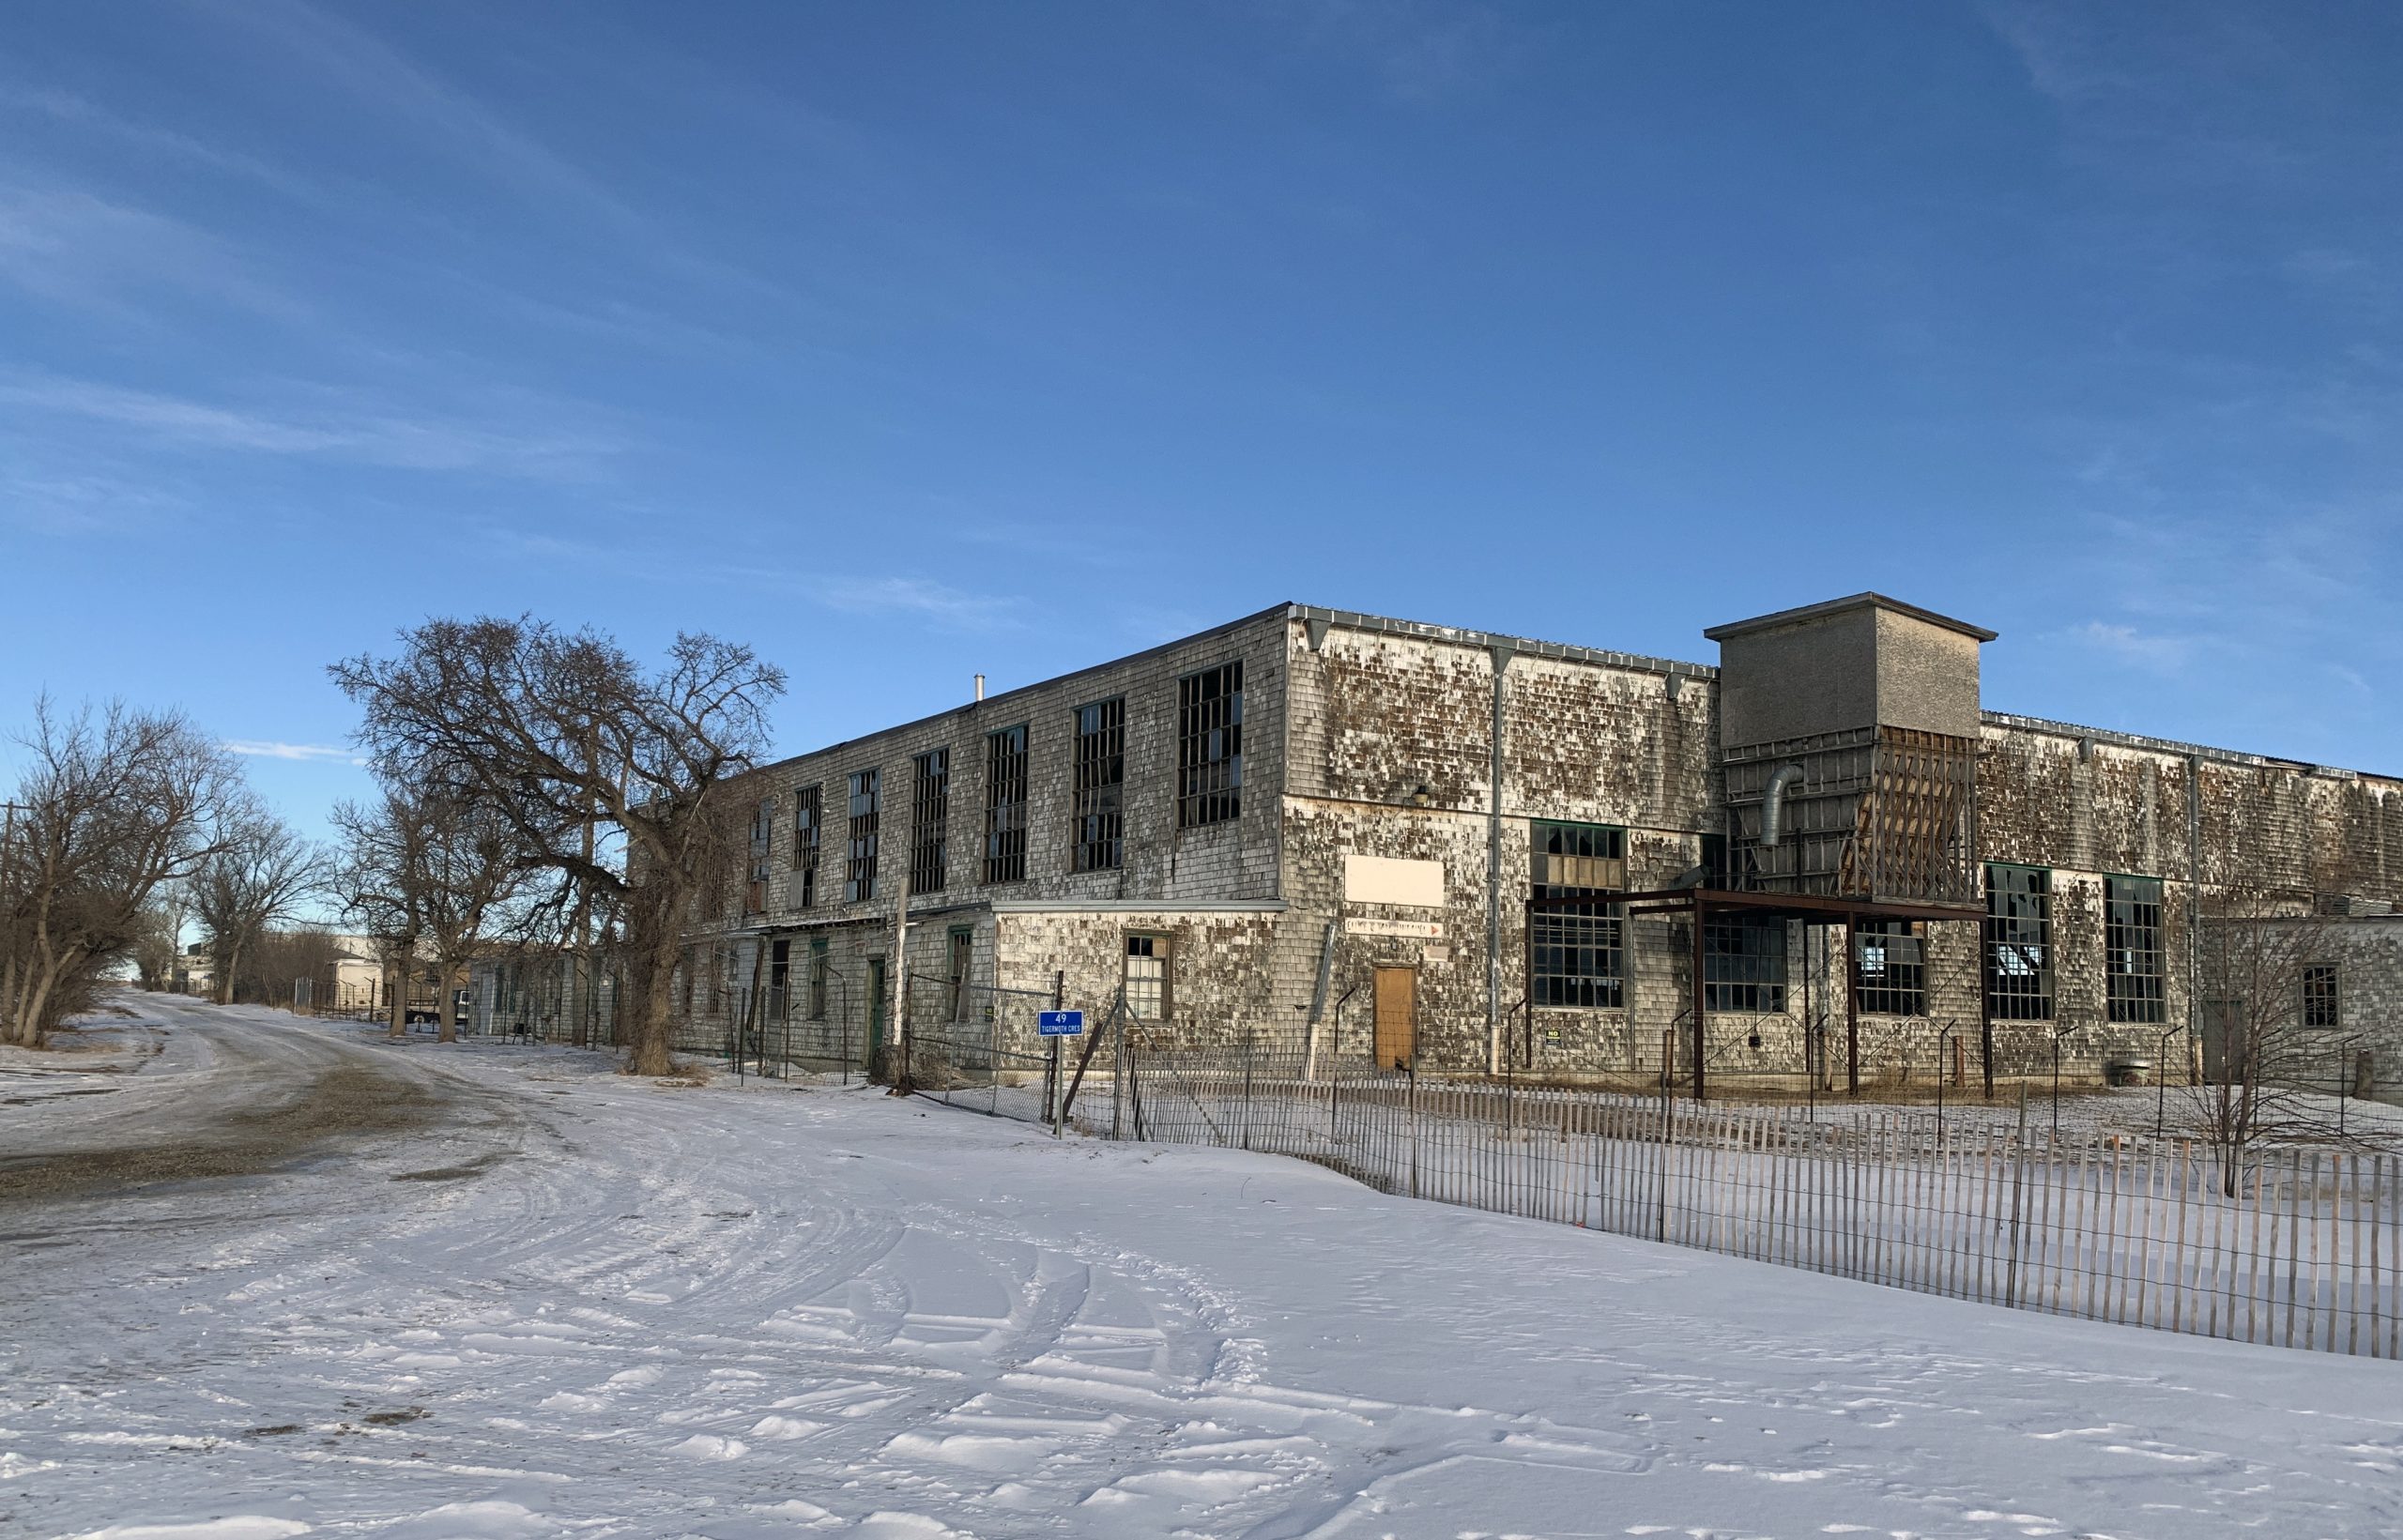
left=0, top=999, right=2403, bottom=1540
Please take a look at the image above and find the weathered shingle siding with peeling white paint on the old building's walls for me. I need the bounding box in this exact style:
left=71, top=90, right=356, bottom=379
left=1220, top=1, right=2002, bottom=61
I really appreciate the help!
left=672, top=605, right=2403, bottom=1081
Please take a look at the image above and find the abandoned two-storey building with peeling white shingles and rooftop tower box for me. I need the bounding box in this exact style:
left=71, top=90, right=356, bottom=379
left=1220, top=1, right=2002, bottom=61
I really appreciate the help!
left=678, top=593, right=2403, bottom=1090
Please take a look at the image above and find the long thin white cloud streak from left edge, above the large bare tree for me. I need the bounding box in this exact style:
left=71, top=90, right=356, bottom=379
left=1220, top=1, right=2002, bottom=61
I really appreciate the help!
left=0, top=374, right=620, bottom=480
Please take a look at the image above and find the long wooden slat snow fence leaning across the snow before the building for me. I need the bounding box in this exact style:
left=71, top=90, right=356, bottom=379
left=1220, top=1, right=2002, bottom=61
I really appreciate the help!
left=1095, top=1050, right=2403, bottom=1357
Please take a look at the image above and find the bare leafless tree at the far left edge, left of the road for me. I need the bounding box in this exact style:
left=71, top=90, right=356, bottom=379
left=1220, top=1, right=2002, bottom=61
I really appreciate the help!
left=0, top=699, right=243, bottom=1047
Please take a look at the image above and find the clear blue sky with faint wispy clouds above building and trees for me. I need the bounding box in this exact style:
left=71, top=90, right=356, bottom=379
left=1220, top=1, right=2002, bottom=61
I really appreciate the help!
left=0, top=0, right=2403, bottom=841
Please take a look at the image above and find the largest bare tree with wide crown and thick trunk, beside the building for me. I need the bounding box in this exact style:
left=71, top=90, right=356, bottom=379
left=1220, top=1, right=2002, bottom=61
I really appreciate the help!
left=331, top=618, right=784, bottom=1074
